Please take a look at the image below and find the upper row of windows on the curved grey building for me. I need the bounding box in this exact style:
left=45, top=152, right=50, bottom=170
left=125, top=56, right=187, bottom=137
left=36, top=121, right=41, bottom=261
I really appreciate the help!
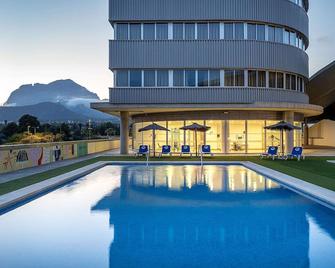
left=116, top=22, right=306, bottom=50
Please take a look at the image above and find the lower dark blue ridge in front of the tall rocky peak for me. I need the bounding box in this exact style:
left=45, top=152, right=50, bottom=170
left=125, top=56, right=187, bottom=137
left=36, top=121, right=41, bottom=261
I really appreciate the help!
left=0, top=102, right=89, bottom=122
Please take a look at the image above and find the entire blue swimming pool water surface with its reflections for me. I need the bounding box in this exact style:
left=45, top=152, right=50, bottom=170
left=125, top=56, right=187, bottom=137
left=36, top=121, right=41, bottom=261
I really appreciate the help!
left=0, top=165, right=335, bottom=268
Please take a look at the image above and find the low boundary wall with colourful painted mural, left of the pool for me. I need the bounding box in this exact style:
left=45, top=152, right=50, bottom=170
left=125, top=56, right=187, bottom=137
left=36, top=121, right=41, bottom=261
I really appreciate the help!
left=0, top=140, right=120, bottom=174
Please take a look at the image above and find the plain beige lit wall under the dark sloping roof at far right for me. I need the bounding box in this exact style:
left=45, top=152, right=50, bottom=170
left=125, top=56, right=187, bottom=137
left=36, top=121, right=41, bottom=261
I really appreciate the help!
left=309, top=120, right=335, bottom=147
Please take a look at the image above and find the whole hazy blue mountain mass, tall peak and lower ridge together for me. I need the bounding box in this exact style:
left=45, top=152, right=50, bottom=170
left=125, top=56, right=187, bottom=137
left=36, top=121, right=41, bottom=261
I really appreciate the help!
left=0, top=79, right=117, bottom=121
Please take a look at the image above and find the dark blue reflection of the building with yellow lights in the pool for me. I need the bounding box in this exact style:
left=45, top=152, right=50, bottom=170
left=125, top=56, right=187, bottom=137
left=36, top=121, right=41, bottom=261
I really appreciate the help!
left=92, top=166, right=310, bottom=267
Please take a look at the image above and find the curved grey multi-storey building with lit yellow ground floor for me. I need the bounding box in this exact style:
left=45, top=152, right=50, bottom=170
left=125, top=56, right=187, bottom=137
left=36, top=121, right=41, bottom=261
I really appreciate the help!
left=92, top=0, right=322, bottom=153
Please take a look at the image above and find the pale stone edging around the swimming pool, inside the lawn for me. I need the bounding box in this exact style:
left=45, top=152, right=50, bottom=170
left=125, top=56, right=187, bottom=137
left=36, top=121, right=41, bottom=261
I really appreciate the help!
left=0, top=161, right=335, bottom=211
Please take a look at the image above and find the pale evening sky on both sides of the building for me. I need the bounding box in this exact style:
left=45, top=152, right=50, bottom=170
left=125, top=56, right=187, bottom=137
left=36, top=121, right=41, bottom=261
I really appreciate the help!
left=0, top=0, right=335, bottom=104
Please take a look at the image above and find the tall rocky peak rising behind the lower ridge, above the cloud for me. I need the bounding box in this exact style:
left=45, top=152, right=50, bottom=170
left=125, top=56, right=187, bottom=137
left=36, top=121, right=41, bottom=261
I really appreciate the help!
left=5, top=79, right=99, bottom=106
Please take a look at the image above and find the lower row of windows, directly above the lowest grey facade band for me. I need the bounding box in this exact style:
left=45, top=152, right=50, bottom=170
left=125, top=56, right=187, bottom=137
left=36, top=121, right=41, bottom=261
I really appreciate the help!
left=115, top=69, right=305, bottom=92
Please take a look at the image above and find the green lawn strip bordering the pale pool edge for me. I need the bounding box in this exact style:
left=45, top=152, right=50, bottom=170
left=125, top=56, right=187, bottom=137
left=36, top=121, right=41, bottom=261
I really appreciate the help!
left=0, top=156, right=335, bottom=195
